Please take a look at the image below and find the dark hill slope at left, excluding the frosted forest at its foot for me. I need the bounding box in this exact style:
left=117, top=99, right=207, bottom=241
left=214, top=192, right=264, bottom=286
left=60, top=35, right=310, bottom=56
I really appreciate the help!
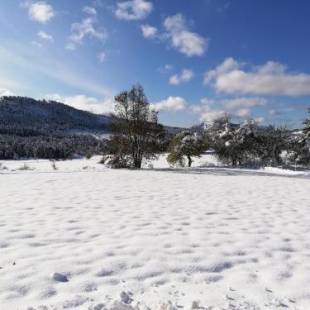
left=0, top=97, right=110, bottom=136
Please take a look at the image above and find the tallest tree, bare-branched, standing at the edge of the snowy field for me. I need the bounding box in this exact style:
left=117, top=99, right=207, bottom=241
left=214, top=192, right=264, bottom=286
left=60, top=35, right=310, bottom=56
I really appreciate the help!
left=107, top=85, right=164, bottom=168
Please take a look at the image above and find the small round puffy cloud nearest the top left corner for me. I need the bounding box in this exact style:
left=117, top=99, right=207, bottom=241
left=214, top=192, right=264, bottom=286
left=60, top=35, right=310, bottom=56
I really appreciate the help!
left=24, top=1, right=55, bottom=24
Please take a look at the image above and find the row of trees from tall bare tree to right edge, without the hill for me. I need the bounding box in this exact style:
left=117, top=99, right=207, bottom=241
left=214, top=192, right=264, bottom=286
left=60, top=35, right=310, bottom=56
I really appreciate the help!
left=103, top=86, right=310, bottom=168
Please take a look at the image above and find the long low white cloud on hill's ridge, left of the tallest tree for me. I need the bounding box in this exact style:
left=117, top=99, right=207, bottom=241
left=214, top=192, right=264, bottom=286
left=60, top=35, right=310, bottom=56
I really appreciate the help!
left=44, top=94, right=115, bottom=114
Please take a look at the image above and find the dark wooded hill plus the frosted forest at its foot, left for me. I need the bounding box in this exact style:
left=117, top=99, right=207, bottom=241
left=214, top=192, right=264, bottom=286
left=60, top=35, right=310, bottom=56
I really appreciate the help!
left=0, top=97, right=110, bottom=159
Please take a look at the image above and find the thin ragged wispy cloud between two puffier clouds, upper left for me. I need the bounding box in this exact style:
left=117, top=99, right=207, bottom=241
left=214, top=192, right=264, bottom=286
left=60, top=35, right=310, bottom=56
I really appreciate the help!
left=66, top=17, right=107, bottom=50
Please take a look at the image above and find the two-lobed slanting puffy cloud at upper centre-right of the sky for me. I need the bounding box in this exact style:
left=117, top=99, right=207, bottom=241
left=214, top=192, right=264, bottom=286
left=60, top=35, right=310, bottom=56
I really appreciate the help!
left=164, top=14, right=207, bottom=57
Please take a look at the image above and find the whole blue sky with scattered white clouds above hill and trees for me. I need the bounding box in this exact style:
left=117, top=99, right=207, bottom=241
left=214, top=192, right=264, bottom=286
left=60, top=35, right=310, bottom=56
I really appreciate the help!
left=0, top=0, right=310, bottom=127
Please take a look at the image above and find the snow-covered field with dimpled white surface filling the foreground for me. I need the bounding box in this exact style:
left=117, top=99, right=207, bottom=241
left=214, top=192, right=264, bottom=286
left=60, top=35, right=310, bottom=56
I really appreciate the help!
left=0, top=156, right=310, bottom=310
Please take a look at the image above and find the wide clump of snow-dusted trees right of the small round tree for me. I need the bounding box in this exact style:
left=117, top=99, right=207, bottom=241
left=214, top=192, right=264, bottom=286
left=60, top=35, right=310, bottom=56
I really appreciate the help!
left=207, top=118, right=310, bottom=166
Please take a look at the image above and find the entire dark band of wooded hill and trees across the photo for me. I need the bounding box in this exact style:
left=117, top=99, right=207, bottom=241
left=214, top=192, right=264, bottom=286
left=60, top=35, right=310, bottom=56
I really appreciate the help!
left=0, top=85, right=310, bottom=168
